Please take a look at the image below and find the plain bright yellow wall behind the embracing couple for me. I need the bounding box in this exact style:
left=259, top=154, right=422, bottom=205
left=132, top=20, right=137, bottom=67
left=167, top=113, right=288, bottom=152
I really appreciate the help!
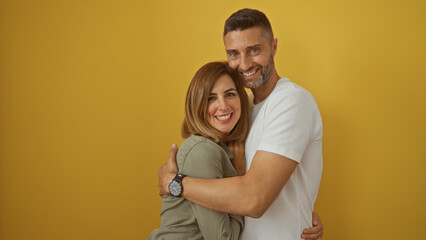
left=0, top=0, right=426, bottom=240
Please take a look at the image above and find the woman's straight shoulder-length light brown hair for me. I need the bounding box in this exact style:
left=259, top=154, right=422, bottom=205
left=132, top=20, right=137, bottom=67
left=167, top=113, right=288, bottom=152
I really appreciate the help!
left=181, top=62, right=250, bottom=143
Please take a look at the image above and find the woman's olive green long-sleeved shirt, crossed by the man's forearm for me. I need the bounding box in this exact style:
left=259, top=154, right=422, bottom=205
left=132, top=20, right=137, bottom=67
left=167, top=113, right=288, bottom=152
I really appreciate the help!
left=148, top=136, right=244, bottom=240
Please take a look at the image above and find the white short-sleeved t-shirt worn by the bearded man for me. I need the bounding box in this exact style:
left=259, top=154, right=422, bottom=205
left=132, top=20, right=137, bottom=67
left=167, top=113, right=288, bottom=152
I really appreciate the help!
left=241, top=78, right=322, bottom=240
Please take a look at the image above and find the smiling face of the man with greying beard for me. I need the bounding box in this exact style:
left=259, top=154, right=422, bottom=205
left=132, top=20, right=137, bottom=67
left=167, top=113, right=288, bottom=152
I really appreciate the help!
left=224, top=27, right=277, bottom=88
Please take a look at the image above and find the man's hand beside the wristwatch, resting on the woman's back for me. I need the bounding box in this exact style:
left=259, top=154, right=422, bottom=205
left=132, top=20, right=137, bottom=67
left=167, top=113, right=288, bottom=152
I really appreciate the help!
left=158, top=144, right=178, bottom=196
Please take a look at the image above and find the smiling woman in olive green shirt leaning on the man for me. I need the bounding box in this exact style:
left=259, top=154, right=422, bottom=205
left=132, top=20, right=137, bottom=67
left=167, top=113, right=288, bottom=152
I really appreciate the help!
left=148, top=62, right=249, bottom=240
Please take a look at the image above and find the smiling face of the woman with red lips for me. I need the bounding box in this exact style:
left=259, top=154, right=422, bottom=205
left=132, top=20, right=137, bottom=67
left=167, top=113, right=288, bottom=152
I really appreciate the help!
left=206, top=74, right=241, bottom=133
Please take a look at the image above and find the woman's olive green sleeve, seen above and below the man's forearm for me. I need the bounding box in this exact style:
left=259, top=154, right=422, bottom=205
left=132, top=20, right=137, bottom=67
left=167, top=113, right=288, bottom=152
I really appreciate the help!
left=181, top=142, right=244, bottom=240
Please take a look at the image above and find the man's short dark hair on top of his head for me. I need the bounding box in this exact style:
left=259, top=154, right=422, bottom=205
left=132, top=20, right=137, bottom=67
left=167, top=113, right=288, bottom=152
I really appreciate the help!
left=223, top=8, right=274, bottom=42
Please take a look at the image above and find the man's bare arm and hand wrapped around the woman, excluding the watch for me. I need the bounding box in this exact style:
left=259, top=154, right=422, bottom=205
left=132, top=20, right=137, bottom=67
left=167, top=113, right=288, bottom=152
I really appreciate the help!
left=159, top=148, right=297, bottom=218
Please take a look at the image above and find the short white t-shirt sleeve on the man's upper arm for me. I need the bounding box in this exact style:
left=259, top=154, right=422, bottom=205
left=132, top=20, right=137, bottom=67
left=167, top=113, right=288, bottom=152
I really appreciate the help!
left=258, top=91, right=317, bottom=163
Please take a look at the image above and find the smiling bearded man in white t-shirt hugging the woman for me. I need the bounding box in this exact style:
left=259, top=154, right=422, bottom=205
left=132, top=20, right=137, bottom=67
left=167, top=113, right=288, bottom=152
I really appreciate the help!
left=158, top=9, right=322, bottom=240
